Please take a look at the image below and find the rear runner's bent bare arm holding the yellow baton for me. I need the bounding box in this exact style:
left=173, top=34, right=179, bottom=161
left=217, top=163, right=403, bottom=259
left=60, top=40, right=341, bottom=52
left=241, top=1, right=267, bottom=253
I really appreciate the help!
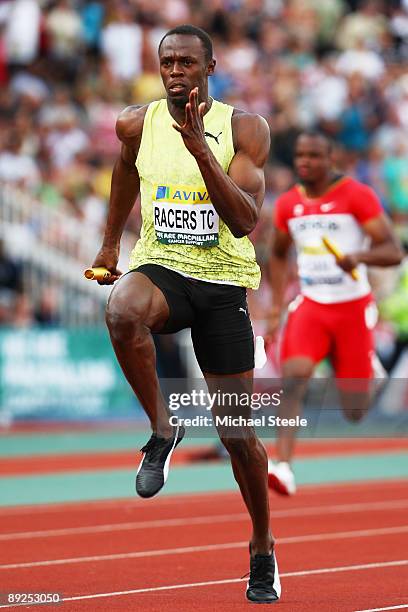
left=337, top=215, right=404, bottom=272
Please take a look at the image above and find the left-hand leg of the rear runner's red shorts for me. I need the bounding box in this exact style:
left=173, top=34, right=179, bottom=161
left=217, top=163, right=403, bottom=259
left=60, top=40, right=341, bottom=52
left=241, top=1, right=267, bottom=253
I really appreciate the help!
left=281, top=296, right=331, bottom=364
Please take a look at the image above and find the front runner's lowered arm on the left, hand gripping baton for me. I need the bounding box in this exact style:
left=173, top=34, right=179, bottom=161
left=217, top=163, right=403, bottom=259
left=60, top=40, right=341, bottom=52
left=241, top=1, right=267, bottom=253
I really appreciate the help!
left=93, top=107, right=147, bottom=284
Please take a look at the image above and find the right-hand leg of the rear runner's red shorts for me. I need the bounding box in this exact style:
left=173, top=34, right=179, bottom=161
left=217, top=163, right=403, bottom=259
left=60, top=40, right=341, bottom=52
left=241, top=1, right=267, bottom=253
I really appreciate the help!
left=332, top=297, right=377, bottom=379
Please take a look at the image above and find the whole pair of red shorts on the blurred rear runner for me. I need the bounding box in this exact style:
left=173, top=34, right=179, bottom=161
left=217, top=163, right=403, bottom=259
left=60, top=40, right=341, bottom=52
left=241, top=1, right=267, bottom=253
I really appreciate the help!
left=281, top=294, right=377, bottom=378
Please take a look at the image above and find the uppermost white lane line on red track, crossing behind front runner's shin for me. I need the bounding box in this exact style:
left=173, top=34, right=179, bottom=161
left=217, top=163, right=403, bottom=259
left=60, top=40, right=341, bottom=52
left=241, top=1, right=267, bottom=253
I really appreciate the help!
left=0, top=499, right=408, bottom=541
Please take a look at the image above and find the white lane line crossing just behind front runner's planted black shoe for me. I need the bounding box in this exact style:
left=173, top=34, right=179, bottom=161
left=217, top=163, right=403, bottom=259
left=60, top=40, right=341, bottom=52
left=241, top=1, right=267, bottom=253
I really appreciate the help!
left=0, top=559, right=408, bottom=612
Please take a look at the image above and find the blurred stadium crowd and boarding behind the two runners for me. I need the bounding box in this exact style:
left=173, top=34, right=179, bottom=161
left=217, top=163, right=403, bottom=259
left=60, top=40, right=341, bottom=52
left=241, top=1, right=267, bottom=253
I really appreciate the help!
left=0, top=0, right=408, bottom=428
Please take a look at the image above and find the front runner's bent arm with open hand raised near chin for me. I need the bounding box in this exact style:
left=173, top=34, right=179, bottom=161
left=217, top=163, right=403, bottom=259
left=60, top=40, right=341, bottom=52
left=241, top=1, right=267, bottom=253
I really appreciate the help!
left=173, top=89, right=270, bottom=238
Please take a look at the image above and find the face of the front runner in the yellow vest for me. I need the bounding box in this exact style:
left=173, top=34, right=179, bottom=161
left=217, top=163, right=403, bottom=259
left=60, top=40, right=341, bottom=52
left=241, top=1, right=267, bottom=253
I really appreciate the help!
left=159, top=34, right=215, bottom=108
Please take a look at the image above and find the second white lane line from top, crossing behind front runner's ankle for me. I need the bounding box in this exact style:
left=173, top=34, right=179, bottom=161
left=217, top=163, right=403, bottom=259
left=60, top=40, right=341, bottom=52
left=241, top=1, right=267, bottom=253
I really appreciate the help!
left=0, top=525, right=408, bottom=570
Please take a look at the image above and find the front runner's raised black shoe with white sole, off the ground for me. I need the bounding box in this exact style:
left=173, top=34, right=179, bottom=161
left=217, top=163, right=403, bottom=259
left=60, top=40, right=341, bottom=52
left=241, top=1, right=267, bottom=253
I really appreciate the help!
left=136, top=425, right=185, bottom=497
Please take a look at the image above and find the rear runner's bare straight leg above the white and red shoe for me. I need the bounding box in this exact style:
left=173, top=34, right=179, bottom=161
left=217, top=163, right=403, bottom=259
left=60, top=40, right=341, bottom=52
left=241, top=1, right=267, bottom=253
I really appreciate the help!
left=276, top=357, right=315, bottom=463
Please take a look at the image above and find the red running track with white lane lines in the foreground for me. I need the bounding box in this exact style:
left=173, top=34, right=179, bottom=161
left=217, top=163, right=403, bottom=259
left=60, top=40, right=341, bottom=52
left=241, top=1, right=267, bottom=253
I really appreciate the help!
left=0, top=481, right=408, bottom=612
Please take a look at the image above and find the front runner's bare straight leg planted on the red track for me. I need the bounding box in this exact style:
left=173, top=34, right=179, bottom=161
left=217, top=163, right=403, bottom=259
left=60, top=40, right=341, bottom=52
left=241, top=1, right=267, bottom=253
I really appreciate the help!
left=204, top=370, right=274, bottom=555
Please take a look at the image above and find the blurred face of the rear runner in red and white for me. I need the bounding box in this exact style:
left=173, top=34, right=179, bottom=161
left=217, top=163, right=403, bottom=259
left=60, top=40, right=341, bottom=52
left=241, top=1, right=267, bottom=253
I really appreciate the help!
left=294, top=136, right=331, bottom=183
